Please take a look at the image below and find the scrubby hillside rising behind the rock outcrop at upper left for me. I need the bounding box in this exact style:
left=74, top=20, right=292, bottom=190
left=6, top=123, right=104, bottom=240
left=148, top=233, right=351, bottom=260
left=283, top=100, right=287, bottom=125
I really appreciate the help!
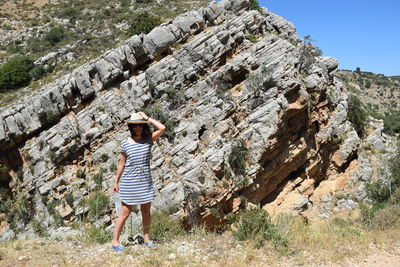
left=0, top=0, right=207, bottom=107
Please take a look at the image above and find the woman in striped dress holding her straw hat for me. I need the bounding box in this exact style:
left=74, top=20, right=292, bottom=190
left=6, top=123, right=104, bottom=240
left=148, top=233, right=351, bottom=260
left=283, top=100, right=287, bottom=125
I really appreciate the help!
left=112, top=112, right=165, bottom=251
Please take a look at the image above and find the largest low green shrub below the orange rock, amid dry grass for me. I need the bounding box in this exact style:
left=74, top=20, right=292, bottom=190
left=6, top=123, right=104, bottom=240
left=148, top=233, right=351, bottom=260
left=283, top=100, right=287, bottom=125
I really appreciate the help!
left=233, top=208, right=288, bottom=248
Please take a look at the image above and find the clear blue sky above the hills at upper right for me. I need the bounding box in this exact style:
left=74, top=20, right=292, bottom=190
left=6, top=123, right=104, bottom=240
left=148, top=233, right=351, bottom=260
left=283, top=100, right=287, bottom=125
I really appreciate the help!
left=252, top=0, right=400, bottom=76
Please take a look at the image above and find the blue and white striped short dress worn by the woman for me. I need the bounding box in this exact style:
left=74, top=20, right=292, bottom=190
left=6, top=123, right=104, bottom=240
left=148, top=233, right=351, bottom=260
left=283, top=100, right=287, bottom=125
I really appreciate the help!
left=119, top=140, right=155, bottom=205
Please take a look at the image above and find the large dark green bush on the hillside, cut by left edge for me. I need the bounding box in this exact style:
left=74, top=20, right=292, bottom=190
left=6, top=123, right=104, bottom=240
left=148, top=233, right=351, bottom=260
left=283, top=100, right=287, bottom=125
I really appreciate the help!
left=0, top=56, right=34, bottom=92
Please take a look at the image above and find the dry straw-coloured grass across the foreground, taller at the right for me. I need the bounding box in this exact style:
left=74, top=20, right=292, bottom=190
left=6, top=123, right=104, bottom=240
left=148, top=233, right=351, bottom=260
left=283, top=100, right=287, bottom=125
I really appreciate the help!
left=0, top=217, right=400, bottom=266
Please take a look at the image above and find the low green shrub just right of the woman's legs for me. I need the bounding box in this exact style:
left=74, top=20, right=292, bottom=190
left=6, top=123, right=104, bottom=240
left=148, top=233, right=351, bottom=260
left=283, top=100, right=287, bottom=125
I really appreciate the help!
left=150, top=212, right=184, bottom=242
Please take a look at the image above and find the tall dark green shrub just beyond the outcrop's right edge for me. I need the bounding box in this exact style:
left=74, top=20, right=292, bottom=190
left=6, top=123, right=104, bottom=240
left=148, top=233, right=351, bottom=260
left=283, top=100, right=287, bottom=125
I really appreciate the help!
left=347, top=95, right=367, bottom=137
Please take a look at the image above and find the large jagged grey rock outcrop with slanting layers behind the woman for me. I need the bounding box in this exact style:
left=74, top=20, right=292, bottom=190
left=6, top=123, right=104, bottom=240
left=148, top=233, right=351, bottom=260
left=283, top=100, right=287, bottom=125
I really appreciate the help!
left=0, top=0, right=394, bottom=239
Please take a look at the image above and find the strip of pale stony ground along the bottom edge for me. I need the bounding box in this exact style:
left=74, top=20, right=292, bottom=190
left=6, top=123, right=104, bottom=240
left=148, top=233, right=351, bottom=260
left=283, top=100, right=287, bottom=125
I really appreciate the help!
left=0, top=232, right=400, bottom=267
